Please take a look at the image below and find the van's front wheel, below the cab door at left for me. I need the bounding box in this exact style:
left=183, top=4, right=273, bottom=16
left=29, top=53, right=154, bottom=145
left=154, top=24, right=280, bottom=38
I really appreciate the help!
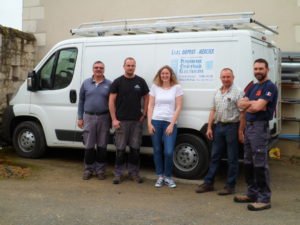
left=13, top=121, right=46, bottom=158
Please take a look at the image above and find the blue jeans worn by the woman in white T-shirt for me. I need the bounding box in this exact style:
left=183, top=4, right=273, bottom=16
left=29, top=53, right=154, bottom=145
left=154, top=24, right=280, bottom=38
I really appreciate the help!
left=152, top=120, right=177, bottom=177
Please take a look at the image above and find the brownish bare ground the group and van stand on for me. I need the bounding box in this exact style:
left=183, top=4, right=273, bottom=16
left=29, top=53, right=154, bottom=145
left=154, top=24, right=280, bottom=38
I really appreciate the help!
left=0, top=150, right=300, bottom=225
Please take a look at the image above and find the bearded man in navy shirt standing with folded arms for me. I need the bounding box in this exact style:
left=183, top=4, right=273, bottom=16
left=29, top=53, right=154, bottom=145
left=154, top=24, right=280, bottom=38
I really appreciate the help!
left=234, top=59, right=278, bottom=211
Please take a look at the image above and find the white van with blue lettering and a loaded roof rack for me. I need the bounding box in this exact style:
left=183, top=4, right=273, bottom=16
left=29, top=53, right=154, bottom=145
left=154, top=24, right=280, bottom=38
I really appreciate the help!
left=3, top=13, right=281, bottom=178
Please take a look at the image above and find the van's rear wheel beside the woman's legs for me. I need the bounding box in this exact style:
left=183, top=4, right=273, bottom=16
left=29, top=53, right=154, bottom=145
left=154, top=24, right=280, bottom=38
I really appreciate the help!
left=173, top=134, right=209, bottom=179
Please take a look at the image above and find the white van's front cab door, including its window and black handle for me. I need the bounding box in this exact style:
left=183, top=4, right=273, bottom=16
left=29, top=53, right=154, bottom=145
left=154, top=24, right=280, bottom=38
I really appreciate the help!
left=30, top=44, right=81, bottom=147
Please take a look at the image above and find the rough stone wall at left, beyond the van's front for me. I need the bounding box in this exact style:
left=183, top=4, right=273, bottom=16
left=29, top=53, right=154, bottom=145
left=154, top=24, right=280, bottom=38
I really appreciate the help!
left=0, top=25, right=36, bottom=118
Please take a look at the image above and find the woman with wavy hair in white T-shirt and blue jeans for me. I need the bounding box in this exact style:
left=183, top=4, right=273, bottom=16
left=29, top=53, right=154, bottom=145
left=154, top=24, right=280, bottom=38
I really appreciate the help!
left=148, top=66, right=183, bottom=188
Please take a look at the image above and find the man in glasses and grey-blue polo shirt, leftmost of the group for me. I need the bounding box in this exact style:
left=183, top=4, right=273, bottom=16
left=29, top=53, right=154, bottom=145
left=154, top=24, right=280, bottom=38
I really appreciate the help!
left=77, top=61, right=111, bottom=180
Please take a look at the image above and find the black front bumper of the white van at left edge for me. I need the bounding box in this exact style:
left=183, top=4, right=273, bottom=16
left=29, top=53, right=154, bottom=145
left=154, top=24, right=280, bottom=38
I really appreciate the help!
left=0, top=105, right=15, bottom=144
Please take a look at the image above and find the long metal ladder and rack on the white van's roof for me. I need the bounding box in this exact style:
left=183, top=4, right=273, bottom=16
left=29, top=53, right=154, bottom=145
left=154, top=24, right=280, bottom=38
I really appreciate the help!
left=70, top=12, right=278, bottom=36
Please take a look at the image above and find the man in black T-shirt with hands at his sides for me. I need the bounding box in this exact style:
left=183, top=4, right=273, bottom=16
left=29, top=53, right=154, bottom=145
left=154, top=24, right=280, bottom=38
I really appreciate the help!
left=109, top=57, right=149, bottom=184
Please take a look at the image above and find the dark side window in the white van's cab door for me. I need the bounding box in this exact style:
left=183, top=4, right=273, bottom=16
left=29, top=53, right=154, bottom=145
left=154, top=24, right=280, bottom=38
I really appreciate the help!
left=39, top=48, right=77, bottom=90
